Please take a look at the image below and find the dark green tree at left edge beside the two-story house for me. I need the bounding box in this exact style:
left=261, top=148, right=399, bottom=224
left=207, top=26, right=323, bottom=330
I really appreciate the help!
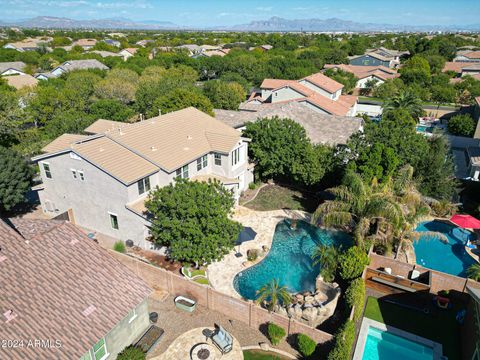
left=0, top=147, right=33, bottom=213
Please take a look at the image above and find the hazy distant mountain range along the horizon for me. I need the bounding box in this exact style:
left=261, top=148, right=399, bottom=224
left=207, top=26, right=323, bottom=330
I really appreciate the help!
left=0, top=16, right=480, bottom=32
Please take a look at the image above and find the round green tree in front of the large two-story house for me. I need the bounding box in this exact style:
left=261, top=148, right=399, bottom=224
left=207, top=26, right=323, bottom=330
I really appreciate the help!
left=145, top=178, right=241, bottom=264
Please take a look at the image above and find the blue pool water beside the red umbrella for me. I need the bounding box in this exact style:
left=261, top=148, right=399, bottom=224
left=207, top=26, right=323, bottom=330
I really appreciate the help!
left=413, top=221, right=475, bottom=277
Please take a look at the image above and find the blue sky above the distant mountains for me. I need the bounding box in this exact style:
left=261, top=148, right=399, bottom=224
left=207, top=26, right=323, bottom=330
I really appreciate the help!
left=0, top=0, right=480, bottom=26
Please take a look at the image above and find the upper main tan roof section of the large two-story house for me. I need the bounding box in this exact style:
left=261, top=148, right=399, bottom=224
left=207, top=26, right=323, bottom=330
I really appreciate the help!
left=108, top=107, right=240, bottom=172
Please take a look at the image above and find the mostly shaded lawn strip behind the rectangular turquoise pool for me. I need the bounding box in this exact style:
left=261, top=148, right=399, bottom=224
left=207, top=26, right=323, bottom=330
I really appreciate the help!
left=365, top=297, right=460, bottom=360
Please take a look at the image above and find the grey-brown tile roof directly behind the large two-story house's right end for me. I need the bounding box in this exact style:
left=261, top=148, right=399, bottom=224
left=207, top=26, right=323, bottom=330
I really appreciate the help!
left=215, top=102, right=363, bottom=145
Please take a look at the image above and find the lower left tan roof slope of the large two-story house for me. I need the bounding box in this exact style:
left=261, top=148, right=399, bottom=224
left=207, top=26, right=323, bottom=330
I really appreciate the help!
left=71, top=136, right=158, bottom=184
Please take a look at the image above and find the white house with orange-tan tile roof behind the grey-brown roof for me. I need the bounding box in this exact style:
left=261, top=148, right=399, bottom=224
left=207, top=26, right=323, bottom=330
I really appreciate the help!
left=248, top=73, right=357, bottom=116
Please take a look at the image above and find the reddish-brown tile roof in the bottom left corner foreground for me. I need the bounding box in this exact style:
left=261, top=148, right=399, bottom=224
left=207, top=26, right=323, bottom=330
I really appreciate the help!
left=0, top=219, right=151, bottom=359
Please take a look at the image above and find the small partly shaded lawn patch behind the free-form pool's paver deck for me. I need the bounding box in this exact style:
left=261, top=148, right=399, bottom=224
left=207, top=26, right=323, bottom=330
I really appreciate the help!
left=245, top=185, right=319, bottom=212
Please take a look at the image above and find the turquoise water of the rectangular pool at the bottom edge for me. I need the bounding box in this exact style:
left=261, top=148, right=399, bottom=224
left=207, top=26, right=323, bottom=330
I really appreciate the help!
left=362, top=326, right=433, bottom=360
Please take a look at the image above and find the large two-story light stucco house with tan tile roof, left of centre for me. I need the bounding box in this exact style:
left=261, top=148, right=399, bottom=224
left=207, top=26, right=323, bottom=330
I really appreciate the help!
left=34, top=108, right=253, bottom=248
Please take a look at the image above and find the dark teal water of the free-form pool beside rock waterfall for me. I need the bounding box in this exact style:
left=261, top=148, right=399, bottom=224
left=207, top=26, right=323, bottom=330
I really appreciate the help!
left=233, top=221, right=352, bottom=300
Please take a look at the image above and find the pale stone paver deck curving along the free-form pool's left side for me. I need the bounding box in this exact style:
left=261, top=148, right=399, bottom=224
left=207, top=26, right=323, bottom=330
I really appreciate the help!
left=208, top=206, right=310, bottom=298
